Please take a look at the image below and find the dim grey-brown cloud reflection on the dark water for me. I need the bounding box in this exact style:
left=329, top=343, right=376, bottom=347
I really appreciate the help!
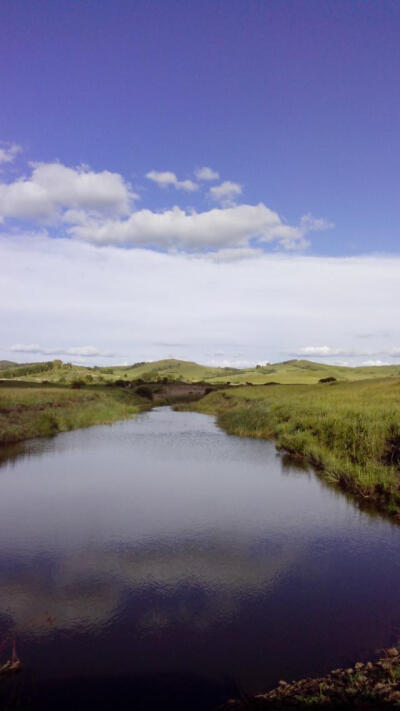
left=0, top=537, right=300, bottom=635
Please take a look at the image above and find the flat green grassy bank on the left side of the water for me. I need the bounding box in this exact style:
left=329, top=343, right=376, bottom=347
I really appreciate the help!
left=0, top=382, right=149, bottom=444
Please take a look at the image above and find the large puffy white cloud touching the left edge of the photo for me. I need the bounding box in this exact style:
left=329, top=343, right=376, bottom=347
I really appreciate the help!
left=0, top=163, right=137, bottom=222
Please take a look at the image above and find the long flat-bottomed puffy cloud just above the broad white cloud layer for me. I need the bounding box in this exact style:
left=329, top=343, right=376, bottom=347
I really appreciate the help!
left=68, top=203, right=328, bottom=254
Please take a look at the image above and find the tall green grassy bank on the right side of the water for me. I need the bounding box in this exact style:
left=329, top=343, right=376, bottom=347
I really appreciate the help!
left=182, top=378, right=400, bottom=518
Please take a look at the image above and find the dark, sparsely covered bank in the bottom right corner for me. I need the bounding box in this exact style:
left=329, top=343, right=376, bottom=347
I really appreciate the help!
left=220, top=647, right=400, bottom=711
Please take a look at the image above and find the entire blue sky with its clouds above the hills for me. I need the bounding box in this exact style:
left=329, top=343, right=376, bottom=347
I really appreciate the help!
left=0, top=0, right=400, bottom=367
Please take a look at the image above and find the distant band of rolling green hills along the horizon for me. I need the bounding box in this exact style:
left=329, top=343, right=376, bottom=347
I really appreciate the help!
left=0, top=359, right=400, bottom=385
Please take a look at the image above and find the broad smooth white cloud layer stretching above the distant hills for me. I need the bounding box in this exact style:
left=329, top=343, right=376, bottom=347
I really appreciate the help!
left=0, top=234, right=400, bottom=364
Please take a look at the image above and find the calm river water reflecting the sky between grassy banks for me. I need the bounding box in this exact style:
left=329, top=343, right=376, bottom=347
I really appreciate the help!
left=0, top=408, right=400, bottom=711
